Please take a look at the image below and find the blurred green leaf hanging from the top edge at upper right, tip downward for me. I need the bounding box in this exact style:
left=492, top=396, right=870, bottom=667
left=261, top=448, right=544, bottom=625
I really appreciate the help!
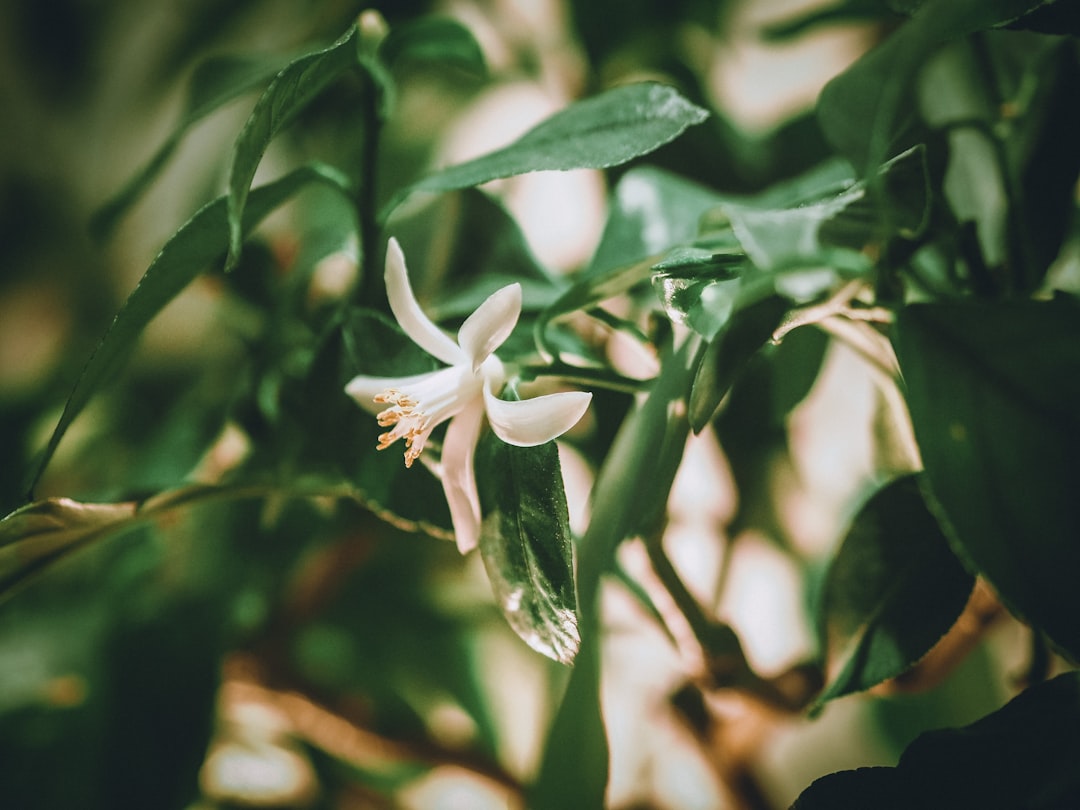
left=818, top=0, right=1042, bottom=174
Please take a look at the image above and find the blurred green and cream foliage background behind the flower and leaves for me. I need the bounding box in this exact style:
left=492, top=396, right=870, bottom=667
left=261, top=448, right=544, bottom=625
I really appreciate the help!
left=0, top=0, right=1076, bottom=810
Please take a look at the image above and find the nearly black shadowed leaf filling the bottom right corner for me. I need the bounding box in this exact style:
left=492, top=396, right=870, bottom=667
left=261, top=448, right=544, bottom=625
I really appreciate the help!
left=792, top=672, right=1080, bottom=810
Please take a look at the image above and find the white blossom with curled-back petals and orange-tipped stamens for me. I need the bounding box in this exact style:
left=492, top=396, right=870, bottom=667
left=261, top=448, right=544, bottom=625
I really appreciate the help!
left=346, top=239, right=592, bottom=554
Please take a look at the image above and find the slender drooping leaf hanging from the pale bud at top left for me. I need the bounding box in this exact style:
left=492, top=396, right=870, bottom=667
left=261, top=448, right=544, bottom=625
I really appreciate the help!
left=226, top=26, right=360, bottom=269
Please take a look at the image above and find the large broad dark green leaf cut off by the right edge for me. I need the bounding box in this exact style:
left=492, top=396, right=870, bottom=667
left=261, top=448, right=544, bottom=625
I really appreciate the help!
left=894, top=295, right=1080, bottom=658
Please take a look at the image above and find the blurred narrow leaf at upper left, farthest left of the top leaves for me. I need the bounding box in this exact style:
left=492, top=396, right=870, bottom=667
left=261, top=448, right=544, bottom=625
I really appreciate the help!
left=90, top=49, right=293, bottom=239
